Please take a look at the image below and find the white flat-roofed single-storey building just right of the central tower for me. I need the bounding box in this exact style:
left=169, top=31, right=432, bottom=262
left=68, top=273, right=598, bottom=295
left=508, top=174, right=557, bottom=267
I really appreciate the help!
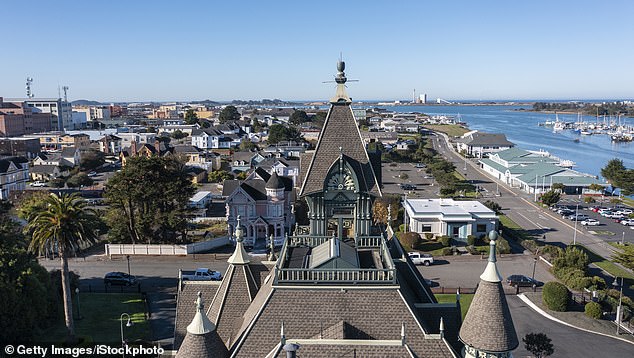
left=404, top=199, right=498, bottom=242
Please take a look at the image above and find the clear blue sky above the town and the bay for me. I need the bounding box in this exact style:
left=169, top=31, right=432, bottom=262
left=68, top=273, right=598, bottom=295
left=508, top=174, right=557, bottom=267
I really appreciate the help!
left=0, top=0, right=634, bottom=101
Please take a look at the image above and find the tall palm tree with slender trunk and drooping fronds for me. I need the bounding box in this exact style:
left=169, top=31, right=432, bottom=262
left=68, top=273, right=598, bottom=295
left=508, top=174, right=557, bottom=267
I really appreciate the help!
left=26, top=193, right=97, bottom=341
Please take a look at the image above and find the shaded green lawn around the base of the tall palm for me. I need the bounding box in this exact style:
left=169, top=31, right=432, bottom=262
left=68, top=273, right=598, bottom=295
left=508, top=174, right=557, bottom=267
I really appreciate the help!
left=36, top=293, right=151, bottom=344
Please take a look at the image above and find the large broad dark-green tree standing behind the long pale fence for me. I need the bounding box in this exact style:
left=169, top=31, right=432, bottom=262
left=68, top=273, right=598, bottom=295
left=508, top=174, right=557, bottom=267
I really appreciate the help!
left=105, top=157, right=196, bottom=244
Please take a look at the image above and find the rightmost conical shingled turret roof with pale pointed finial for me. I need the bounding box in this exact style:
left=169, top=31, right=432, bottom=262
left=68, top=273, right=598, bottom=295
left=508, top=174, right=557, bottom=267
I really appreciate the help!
left=459, top=231, right=519, bottom=353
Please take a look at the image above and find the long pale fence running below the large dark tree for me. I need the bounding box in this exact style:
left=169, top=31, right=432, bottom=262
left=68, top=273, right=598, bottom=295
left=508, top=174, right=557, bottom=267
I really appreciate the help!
left=106, top=237, right=229, bottom=256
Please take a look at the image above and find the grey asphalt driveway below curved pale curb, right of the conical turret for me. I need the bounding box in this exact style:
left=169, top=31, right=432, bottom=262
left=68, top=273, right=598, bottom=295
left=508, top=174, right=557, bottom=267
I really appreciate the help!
left=506, top=295, right=634, bottom=358
